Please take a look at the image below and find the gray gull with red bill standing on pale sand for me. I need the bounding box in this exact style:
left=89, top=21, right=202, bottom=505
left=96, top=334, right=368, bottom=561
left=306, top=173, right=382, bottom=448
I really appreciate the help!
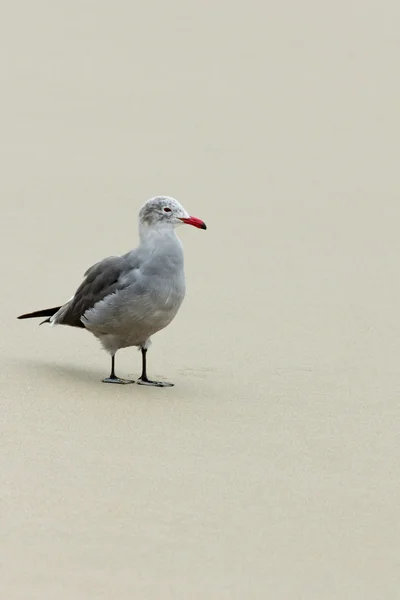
left=17, top=196, right=207, bottom=387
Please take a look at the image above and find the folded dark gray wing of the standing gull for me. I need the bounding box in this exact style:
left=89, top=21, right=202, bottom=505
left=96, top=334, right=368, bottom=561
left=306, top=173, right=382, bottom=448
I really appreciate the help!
left=51, top=256, right=132, bottom=328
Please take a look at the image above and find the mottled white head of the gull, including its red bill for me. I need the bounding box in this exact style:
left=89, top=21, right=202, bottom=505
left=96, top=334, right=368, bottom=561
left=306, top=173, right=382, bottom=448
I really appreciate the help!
left=139, top=196, right=207, bottom=229
